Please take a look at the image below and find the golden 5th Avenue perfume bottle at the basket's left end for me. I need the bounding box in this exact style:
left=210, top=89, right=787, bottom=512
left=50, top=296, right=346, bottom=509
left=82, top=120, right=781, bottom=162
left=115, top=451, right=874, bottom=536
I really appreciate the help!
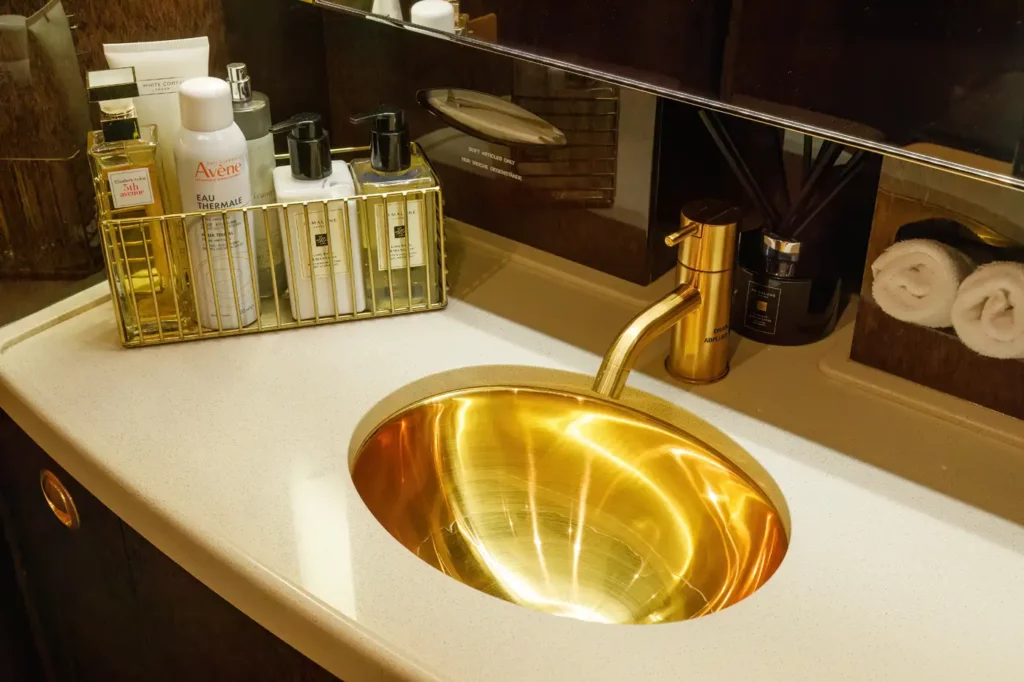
left=88, top=68, right=190, bottom=337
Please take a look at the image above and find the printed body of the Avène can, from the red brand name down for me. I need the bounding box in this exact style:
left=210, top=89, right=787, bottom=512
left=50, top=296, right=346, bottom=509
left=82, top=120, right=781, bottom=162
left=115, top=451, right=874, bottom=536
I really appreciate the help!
left=178, top=154, right=257, bottom=329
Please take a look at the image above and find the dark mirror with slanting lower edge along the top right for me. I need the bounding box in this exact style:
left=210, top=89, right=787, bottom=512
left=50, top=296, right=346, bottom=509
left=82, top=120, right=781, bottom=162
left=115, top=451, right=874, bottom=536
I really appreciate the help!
left=306, top=0, right=1024, bottom=187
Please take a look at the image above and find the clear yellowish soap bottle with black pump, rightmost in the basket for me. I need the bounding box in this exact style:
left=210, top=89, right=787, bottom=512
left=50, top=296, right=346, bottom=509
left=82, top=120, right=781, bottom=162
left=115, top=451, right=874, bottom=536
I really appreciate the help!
left=349, top=108, right=441, bottom=312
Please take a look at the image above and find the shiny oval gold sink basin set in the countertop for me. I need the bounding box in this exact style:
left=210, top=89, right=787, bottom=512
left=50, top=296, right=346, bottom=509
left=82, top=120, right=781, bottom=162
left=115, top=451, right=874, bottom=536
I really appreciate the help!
left=352, top=386, right=787, bottom=624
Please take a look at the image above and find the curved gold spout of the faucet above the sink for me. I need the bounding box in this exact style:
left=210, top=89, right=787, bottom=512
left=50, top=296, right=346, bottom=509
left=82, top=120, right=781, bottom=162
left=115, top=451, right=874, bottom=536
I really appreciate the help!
left=594, top=284, right=700, bottom=398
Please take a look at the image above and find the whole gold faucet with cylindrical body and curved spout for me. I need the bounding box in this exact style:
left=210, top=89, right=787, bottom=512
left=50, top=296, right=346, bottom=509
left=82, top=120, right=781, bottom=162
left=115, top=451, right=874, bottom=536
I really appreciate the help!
left=594, top=200, right=740, bottom=398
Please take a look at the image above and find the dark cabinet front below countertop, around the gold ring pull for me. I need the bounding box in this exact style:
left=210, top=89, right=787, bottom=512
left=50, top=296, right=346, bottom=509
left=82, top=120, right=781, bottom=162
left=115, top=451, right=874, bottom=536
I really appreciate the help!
left=0, top=414, right=337, bottom=682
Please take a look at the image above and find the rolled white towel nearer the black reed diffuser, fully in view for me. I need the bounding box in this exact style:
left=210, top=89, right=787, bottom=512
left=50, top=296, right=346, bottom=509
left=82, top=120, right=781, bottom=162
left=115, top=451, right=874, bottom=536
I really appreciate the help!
left=871, top=240, right=974, bottom=328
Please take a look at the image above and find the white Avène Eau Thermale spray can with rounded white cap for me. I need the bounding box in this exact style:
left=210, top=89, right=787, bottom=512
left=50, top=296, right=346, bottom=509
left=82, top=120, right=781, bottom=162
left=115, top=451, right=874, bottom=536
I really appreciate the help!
left=174, top=78, right=259, bottom=330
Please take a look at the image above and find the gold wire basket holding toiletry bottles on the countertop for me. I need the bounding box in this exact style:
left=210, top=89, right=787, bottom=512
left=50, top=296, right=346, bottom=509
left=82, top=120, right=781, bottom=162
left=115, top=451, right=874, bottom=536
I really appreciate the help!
left=95, top=143, right=447, bottom=348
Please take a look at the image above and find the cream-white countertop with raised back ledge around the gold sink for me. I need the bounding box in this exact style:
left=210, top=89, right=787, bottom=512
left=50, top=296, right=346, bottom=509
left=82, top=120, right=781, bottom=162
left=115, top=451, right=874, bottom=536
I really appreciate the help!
left=0, top=225, right=1024, bottom=682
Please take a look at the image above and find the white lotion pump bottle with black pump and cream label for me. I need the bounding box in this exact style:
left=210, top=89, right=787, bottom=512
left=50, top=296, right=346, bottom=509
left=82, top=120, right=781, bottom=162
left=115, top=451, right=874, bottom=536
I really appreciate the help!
left=270, top=114, right=367, bottom=319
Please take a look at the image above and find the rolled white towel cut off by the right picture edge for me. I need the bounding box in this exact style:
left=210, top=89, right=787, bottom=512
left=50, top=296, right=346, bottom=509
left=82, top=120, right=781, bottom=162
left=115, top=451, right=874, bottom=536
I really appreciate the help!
left=952, top=262, right=1024, bottom=358
